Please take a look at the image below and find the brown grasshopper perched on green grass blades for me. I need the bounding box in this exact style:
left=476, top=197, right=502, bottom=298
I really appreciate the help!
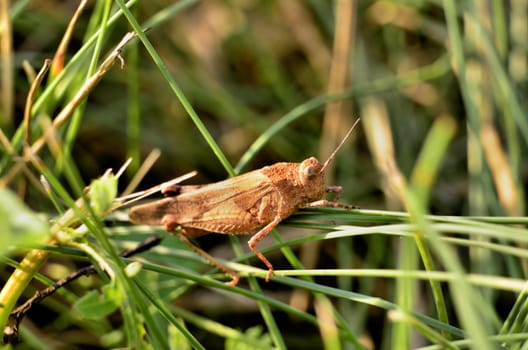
left=128, top=119, right=359, bottom=286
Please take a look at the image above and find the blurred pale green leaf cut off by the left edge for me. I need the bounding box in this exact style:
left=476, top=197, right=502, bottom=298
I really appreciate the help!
left=0, top=188, right=49, bottom=255
